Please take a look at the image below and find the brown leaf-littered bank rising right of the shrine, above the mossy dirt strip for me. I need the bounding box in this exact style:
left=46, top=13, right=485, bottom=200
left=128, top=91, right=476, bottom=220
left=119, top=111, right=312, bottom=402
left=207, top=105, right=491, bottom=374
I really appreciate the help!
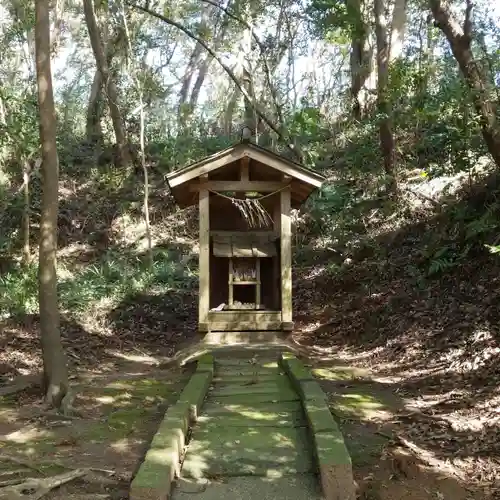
left=293, top=203, right=500, bottom=498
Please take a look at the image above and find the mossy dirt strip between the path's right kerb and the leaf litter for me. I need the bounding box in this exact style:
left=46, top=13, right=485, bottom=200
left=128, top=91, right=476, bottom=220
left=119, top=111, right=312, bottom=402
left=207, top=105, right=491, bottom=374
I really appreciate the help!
left=300, top=358, right=500, bottom=500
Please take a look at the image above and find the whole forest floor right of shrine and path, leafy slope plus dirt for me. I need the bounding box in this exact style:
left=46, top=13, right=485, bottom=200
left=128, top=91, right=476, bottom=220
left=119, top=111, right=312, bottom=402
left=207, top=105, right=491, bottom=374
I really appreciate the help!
left=293, top=233, right=500, bottom=500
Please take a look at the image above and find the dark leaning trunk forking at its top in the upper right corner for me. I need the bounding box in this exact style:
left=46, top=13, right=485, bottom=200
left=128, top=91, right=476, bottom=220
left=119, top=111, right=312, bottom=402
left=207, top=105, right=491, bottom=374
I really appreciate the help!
left=429, top=0, right=500, bottom=168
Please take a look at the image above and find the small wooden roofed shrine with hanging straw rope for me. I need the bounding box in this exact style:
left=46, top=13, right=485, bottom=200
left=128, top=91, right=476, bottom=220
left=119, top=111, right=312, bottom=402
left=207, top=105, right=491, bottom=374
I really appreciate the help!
left=167, top=142, right=324, bottom=332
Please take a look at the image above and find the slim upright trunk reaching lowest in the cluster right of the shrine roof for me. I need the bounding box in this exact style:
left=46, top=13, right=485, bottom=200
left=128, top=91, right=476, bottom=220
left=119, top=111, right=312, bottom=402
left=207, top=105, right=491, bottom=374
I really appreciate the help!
left=374, top=0, right=397, bottom=193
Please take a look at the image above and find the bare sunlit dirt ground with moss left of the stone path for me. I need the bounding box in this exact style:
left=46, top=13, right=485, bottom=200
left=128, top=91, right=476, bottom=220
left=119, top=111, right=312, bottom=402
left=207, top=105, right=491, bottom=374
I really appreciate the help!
left=0, top=355, right=189, bottom=500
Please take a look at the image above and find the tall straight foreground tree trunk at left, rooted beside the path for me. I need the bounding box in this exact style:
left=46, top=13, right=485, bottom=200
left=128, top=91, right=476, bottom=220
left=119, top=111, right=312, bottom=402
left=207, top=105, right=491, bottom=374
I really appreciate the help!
left=35, top=0, right=68, bottom=408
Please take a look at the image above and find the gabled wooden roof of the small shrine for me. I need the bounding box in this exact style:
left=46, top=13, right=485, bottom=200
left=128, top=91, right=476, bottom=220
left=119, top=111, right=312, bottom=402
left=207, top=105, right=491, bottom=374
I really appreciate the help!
left=167, top=142, right=325, bottom=207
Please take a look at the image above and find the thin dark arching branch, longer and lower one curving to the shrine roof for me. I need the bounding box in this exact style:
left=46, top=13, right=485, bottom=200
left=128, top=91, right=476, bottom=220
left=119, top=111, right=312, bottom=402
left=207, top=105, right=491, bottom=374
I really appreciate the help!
left=125, top=0, right=302, bottom=160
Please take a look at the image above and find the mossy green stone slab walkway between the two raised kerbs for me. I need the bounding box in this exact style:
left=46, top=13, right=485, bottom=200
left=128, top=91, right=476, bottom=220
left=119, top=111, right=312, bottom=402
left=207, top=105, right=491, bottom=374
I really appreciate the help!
left=174, top=355, right=320, bottom=500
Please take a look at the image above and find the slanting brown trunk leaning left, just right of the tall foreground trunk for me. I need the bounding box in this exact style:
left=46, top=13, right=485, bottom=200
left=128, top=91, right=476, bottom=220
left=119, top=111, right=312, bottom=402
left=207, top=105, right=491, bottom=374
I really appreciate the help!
left=83, top=0, right=131, bottom=167
